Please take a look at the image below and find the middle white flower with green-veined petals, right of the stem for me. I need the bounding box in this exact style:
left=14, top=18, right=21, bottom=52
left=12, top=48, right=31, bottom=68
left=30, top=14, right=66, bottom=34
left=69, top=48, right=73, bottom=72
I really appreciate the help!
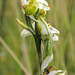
left=39, top=18, right=60, bottom=42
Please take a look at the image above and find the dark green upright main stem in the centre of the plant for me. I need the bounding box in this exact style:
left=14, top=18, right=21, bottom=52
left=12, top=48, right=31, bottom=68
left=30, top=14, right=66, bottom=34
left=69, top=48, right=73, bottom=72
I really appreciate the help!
left=34, top=9, right=42, bottom=68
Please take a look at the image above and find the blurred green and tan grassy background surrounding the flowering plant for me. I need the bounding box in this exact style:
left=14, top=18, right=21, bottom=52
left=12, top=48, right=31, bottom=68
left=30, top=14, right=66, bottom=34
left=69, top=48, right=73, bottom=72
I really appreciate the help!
left=0, top=0, right=75, bottom=75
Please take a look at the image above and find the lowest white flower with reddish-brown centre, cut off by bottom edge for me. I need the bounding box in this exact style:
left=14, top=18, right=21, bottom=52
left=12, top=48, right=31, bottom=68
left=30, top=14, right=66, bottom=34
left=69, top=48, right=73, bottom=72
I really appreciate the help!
left=41, top=54, right=66, bottom=75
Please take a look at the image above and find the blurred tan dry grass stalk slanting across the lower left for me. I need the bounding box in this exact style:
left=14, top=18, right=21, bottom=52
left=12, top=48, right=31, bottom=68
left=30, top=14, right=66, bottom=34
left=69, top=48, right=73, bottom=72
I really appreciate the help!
left=0, top=37, right=31, bottom=75
